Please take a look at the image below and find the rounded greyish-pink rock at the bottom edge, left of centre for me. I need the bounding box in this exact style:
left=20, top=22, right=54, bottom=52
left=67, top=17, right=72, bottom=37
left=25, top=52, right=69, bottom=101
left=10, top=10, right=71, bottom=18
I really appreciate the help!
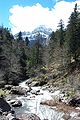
left=17, top=113, right=41, bottom=120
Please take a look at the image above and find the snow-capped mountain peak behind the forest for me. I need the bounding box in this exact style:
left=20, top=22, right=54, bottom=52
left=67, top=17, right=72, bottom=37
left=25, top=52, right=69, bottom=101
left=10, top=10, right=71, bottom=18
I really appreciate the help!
left=15, top=25, right=52, bottom=46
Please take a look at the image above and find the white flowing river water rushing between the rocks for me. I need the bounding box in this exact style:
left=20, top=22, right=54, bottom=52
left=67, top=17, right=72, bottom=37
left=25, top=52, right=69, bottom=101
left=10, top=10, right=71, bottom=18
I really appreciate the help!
left=15, top=81, right=64, bottom=120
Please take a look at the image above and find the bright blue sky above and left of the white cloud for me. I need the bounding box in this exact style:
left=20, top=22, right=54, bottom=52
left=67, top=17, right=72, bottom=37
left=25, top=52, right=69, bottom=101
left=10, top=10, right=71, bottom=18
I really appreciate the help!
left=0, top=0, right=55, bottom=26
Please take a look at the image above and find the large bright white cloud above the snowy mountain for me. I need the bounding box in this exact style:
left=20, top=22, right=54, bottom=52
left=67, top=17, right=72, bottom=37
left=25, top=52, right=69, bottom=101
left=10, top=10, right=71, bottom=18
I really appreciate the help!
left=9, top=0, right=80, bottom=34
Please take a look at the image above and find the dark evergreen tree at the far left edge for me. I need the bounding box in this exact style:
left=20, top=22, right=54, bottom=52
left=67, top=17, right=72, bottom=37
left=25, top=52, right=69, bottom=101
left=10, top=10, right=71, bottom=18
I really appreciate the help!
left=0, top=26, right=14, bottom=83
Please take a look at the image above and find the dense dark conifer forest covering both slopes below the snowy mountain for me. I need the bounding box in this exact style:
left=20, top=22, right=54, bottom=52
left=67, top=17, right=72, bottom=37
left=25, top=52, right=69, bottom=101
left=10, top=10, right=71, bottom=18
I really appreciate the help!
left=0, top=4, right=80, bottom=86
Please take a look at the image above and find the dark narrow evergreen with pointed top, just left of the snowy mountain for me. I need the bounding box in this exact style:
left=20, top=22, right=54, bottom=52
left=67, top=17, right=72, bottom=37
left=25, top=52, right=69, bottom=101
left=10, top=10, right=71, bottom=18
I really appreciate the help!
left=16, top=31, right=28, bottom=80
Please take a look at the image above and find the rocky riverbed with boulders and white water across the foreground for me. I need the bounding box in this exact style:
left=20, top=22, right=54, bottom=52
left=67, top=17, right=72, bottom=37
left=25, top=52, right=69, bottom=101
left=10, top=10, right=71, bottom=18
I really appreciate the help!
left=0, top=79, right=80, bottom=120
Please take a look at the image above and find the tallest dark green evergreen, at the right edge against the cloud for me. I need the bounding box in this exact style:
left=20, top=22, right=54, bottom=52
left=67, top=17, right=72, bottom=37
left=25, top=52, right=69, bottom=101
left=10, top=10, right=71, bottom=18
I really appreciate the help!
left=67, top=4, right=80, bottom=61
